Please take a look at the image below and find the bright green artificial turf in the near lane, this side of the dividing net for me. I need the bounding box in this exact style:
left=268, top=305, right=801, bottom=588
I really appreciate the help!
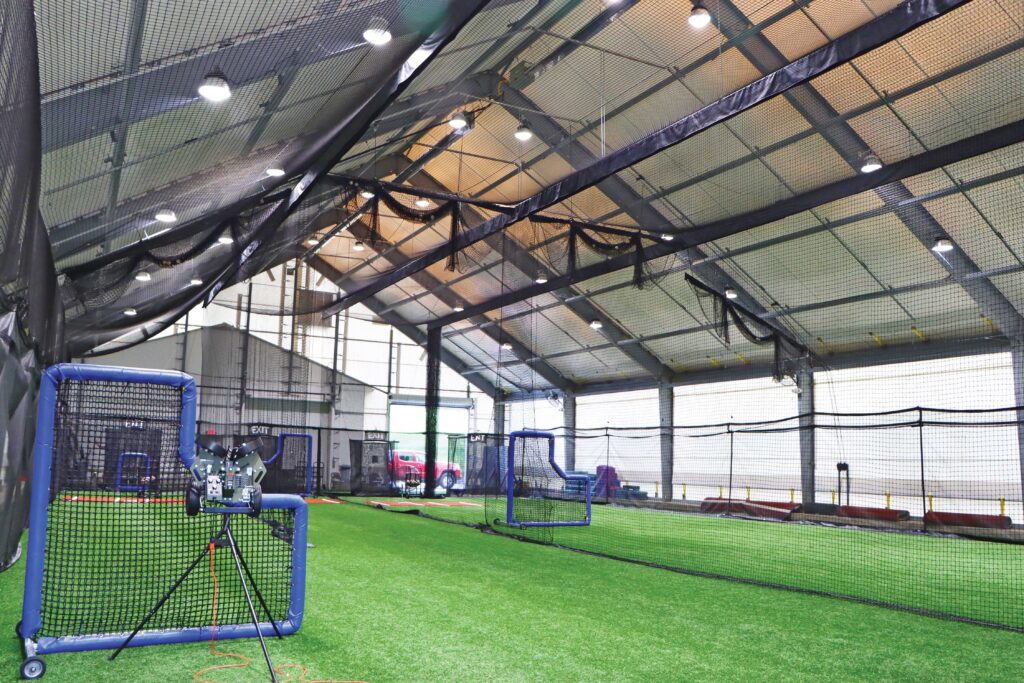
left=0, top=505, right=1024, bottom=683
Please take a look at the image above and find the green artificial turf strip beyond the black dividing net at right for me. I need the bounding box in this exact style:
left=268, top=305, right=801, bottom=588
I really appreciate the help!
left=352, top=498, right=1024, bottom=628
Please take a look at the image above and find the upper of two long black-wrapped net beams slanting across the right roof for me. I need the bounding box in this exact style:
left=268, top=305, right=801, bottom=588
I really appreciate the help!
left=326, top=0, right=967, bottom=315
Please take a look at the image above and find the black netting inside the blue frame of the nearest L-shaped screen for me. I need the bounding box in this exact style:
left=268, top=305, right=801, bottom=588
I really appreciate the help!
left=39, top=381, right=294, bottom=637
